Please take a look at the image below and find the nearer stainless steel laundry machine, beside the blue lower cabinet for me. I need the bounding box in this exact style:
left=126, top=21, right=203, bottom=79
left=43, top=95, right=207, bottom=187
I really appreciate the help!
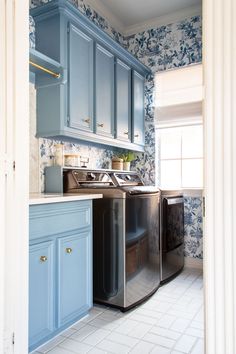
left=63, top=169, right=160, bottom=311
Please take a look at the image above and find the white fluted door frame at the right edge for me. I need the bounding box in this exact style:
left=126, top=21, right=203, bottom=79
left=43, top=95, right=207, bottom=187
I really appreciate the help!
left=203, top=0, right=236, bottom=354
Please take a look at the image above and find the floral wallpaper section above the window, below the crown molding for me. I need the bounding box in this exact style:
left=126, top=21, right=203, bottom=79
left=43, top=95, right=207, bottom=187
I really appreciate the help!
left=123, top=16, right=202, bottom=72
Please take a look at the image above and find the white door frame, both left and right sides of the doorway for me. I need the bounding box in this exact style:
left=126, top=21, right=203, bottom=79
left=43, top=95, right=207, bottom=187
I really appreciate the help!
left=0, top=0, right=236, bottom=354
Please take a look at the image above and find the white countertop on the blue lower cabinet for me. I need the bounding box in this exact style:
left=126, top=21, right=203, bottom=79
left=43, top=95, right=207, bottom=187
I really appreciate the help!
left=29, top=193, right=103, bottom=205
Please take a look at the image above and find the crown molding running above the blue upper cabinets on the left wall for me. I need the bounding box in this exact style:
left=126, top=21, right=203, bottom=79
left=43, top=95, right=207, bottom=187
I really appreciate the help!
left=84, top=0, right=125, bottom=35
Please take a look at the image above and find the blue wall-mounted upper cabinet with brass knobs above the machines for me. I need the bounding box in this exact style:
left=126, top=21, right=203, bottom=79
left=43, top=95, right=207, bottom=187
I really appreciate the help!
left=31, top=0, right=150, bottom=151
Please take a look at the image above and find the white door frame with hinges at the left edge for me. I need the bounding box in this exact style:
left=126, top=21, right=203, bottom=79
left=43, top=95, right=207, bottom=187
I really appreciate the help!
left=0, top=0, right=29, bottom=354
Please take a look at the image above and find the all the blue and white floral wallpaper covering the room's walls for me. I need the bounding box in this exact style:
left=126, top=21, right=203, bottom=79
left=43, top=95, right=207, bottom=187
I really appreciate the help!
left=30, top=0, right=202, bottom=258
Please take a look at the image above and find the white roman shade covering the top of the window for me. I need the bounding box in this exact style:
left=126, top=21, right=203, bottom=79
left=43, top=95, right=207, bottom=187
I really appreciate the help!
left=155, top=64, right=203, bottom=127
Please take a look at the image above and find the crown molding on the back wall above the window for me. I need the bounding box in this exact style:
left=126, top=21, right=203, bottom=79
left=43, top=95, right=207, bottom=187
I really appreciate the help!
left=123, top=5, right=202, bottom=37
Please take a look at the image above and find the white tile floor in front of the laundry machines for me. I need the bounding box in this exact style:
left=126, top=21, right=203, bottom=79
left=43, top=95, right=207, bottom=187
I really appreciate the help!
left=34, top=269, right=204, bottom=354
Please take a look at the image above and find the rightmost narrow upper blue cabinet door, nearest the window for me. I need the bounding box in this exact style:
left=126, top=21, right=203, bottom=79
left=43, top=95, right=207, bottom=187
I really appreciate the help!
left=132, top=71, right=144, bottom=145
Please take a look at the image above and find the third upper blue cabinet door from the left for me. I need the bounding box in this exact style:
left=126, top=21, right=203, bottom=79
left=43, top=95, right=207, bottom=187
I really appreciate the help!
left=116, top=59, right=131, bottom=142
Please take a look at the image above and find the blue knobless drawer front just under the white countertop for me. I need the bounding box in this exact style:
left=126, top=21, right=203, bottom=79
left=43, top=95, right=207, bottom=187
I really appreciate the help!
left=29, top=200, right=92, bottom=240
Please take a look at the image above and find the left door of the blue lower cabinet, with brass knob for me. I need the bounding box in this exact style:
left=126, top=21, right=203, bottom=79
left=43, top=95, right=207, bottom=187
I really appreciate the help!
left=29, top=241, right=54, bottom=347
